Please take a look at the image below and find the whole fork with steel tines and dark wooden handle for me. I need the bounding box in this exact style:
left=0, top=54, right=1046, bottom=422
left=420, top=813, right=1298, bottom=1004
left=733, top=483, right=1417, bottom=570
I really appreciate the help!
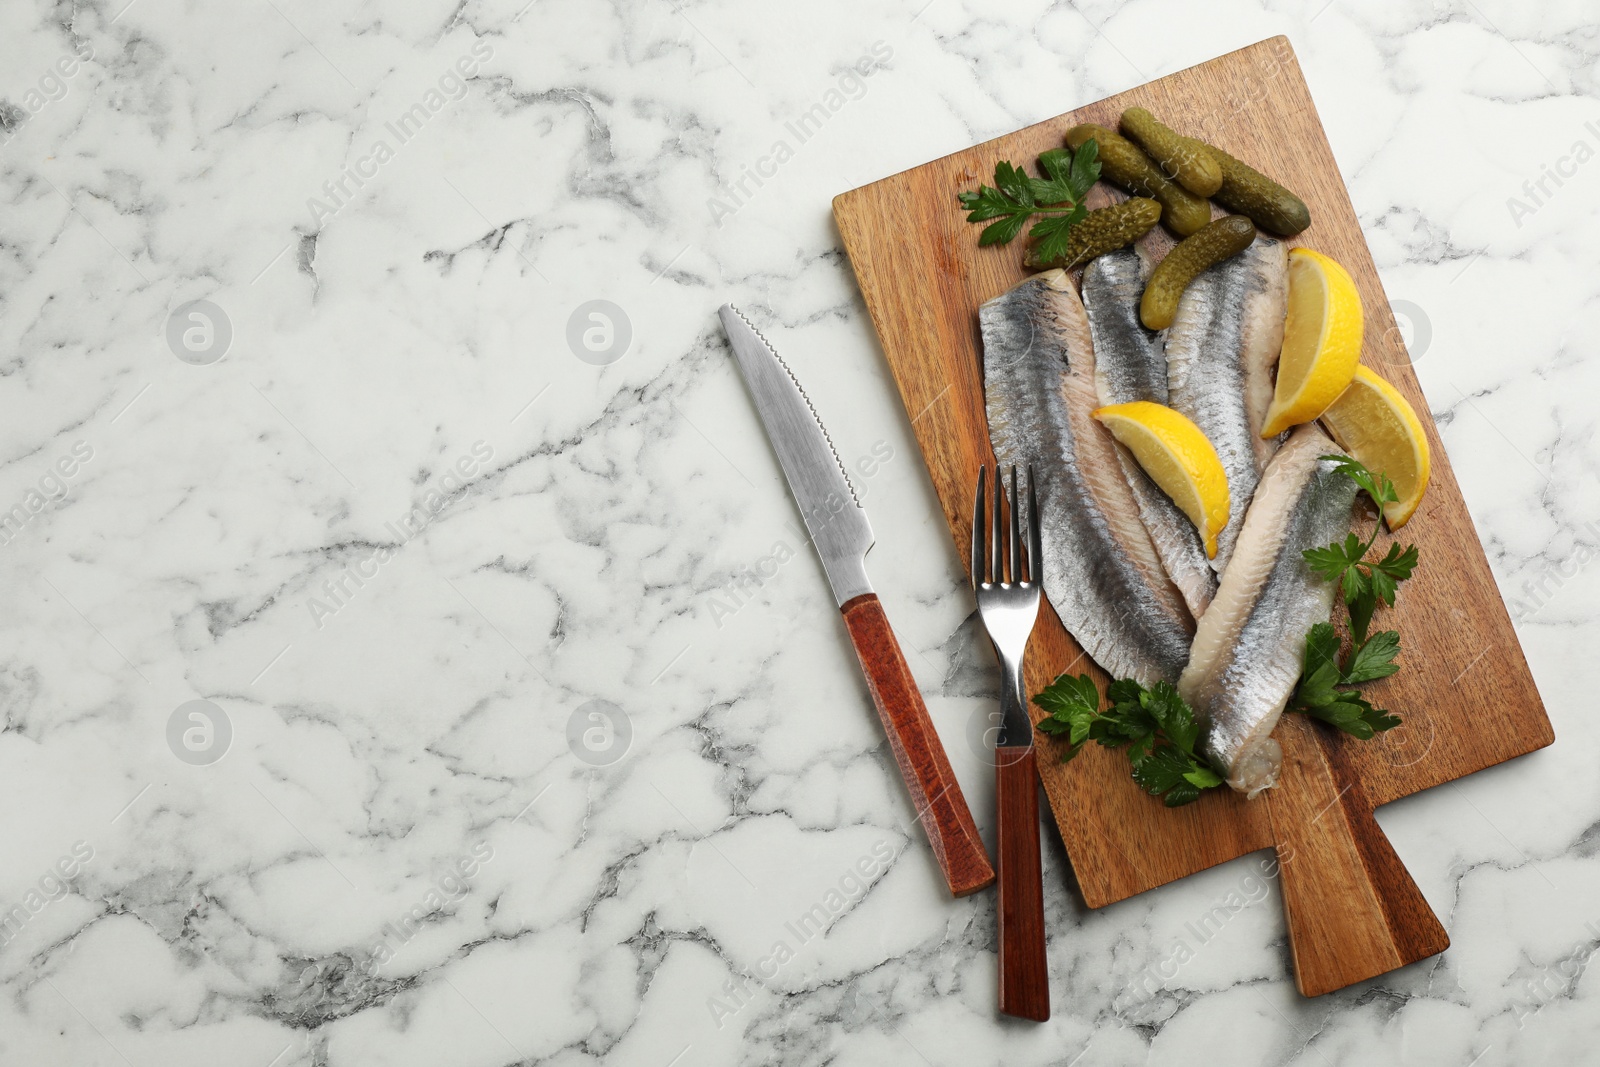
left=973, top=466, right=1050, bottom=1022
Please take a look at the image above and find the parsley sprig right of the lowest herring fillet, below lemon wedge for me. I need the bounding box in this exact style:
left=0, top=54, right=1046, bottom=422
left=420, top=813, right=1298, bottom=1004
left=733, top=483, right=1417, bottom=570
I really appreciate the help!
left=1290, top=456, right=1418, bottom=739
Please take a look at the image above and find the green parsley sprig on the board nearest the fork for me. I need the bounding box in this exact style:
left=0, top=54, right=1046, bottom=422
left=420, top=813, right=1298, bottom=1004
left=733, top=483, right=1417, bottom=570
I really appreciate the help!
left=1034, top=673, right=1222, bottom=808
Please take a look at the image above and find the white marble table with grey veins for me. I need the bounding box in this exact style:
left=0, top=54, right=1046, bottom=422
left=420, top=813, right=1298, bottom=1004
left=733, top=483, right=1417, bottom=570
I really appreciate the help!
left=0, top=0, right=1600, bottom=1067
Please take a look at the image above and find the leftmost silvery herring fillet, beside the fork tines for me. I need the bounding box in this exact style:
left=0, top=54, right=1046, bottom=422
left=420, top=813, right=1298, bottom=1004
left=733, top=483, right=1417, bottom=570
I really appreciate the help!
left=978, top=270, right=1194, bottom=685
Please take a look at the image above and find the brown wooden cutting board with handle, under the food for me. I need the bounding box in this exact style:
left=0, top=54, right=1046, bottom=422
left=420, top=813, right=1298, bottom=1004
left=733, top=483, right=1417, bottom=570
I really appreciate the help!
left=834, top=37, right=1554, bottom=997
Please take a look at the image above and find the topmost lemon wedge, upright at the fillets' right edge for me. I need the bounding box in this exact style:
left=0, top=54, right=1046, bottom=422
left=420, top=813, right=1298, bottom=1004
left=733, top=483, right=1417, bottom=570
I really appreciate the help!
left=1261, top=248, right=1362, bottom=437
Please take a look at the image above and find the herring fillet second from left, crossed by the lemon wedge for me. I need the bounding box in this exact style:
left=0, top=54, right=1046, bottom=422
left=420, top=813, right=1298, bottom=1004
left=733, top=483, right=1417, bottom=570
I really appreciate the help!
left=1083, top=248, right=1216, bottom=619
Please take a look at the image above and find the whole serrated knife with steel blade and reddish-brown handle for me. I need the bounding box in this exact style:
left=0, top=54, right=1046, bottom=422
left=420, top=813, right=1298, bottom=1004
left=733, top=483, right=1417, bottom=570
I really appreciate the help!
left=717, top=304, right=995, bottom=896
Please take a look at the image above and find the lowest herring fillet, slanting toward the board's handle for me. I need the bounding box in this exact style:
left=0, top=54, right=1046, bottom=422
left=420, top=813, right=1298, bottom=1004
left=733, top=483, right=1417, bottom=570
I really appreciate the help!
left=1178, top=424, right=1355, bottom=797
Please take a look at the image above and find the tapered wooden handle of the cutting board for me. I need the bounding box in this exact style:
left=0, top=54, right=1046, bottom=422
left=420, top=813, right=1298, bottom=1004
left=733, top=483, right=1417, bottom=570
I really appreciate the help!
left=1267, top=715, right=1450, bottom=997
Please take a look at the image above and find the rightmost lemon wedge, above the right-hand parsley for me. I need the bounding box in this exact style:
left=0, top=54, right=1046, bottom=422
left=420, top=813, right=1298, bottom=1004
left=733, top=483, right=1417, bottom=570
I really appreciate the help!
left=1322, top=366, right=1427, bottom=530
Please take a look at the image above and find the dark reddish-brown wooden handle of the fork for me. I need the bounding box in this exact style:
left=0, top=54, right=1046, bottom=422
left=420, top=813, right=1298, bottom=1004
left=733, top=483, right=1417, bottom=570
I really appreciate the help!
left=995, top=745, right=1050, bottom=1022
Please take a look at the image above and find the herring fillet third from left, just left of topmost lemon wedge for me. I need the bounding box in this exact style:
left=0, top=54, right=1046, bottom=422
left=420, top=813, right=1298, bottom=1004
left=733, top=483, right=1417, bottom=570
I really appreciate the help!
left=1163, top=234, right=1288, bottom=574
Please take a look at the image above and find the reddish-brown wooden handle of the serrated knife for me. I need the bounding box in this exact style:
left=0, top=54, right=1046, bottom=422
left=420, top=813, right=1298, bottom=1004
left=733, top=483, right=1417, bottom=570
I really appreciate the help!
left=840, top=593, right=995, bottom=896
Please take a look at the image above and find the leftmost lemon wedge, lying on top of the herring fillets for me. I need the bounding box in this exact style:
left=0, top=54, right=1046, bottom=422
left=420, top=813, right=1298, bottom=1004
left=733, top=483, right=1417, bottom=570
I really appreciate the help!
left=1094, top=400, right=1229, bottom=560
